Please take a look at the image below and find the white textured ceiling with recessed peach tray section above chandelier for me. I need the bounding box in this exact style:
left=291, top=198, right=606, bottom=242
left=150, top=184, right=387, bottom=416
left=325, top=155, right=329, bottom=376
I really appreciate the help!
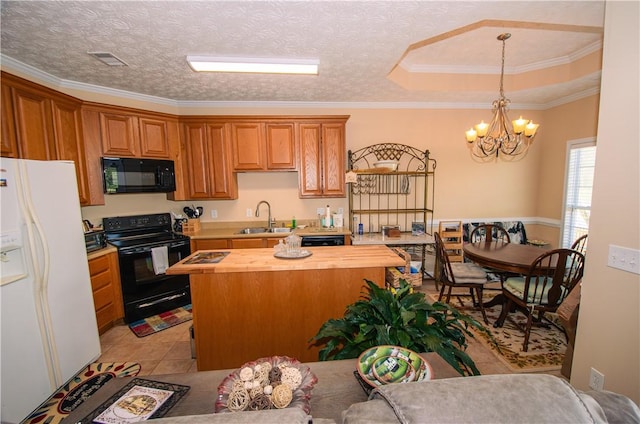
left=1, top=1, right=604, bottom=108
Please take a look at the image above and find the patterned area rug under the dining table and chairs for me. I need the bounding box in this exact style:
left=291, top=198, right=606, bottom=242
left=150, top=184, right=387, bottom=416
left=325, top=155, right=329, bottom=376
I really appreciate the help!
left=429, top=293, right=567, bottom=373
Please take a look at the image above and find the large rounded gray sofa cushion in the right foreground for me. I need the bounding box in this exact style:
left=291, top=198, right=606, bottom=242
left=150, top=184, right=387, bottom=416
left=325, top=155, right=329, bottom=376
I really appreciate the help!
left=343, top=374, right=606, bottom=424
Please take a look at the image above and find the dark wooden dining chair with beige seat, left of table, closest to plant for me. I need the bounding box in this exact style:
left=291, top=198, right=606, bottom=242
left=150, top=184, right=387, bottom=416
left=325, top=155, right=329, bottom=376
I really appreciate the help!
left=433, top=232, right=489, bottom=324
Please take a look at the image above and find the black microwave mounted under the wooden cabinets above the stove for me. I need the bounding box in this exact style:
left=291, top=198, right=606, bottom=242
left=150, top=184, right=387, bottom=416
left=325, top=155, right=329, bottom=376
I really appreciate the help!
left=102, top=158, right=176, bottom=194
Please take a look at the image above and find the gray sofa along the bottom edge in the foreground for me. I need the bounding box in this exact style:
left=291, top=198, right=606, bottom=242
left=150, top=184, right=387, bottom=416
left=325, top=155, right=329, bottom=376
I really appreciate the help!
left=154, top=374, right=640, bottom=424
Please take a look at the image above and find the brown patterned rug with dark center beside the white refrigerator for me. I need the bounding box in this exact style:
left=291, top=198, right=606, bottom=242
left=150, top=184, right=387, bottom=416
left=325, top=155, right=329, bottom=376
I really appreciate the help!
left=23, top=362, right=141, bottom=424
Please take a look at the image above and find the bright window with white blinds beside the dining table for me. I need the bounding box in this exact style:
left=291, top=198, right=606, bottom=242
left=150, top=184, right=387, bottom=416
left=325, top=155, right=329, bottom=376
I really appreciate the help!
left=562, top=139, right=596, bottom=248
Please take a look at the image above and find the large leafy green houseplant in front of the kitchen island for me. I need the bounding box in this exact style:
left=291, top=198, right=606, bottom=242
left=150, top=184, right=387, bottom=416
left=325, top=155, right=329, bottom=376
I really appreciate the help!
left=311, top=280, right=486, bottom=375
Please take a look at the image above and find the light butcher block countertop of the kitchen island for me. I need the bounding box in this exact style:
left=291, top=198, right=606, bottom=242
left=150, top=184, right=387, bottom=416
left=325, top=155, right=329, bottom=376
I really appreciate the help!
left=167, top=245, right=405, bottom=274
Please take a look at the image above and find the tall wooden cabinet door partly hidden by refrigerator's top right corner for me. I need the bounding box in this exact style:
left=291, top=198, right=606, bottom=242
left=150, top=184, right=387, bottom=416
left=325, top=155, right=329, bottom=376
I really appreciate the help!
left=51, top=99, right=90, bottom=205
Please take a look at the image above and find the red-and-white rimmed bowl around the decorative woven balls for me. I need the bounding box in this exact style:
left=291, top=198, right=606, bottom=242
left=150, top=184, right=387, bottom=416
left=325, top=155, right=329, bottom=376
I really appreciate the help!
left=215, top=356, right=318, bottom=414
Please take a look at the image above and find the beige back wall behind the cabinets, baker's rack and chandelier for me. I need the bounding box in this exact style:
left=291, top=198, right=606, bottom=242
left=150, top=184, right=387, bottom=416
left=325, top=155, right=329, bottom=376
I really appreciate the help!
left=83, top=108, right=552, bottom=230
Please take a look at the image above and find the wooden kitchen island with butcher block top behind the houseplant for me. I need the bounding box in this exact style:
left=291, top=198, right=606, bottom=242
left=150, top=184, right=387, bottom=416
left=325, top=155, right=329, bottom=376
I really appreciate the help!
left=167, top=246, right=404, bottom=371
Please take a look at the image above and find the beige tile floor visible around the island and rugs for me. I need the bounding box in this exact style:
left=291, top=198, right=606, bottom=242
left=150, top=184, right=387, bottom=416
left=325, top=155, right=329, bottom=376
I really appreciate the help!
left=98, top=280, right=561, bottom=377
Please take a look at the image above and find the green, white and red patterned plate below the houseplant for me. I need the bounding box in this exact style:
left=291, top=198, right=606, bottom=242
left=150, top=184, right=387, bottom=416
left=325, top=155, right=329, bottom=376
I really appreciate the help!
left=357, top=345, right=433, bottom=387
